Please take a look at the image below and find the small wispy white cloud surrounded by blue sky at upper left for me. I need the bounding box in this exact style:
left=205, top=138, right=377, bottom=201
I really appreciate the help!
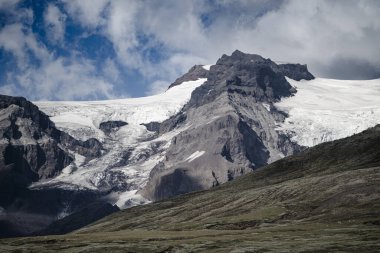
left=44, top=4, right=66, bottom=42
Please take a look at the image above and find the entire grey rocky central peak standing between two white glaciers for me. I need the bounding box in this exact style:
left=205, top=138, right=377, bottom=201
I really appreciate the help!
left=142, top=51, right=310, bottom=200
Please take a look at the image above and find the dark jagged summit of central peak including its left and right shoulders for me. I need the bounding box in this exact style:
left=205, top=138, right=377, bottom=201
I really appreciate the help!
left=169, top=50, right=314, bottom=101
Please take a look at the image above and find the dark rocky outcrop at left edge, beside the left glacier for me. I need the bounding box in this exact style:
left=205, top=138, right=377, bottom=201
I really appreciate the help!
left=0, top=95, right=102, bottom=198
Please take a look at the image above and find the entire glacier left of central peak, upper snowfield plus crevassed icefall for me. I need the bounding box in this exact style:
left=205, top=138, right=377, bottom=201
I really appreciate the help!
left=31, top=78, right=207, bottom=208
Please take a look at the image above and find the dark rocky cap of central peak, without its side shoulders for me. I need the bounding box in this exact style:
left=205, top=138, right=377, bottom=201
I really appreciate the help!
left=184, top=50, right=295, bottom=107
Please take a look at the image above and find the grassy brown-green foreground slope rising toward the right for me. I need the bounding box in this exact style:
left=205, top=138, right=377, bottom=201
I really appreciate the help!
left=0, top=125, right=380, bottom=252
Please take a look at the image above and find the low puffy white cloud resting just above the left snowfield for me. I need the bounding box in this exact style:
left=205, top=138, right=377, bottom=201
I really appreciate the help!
left=0, top=54, right=115, bottom=100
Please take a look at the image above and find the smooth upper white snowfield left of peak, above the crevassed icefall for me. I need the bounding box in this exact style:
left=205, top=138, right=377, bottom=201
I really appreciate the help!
left=34, top=78, right=207, bottom=140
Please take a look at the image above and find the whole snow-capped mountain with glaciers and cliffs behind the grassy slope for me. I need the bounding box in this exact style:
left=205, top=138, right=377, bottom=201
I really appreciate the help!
left=0, top=51, right=380, bottom=236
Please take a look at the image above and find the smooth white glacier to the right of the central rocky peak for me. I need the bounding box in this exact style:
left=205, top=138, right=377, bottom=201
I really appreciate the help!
left=275, top=78, right=380, bottom=147
